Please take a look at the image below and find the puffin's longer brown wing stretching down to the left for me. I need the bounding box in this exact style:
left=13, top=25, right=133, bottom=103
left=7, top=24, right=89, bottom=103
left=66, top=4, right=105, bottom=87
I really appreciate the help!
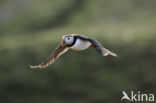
left=30, top=45, right=68, bottom=69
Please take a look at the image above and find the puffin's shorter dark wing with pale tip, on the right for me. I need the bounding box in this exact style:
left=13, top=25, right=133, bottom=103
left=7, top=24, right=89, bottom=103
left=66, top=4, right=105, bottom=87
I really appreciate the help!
left=88, top=39, right=118, bottom=57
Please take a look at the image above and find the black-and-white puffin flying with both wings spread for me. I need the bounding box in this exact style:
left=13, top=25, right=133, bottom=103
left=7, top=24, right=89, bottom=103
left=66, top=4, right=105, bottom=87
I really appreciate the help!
left=30, top=34, right=118, bottom=69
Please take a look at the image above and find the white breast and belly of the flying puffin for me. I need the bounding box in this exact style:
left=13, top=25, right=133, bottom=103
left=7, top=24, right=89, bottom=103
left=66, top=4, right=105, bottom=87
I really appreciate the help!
left=70, top=39, right=91, bottom=50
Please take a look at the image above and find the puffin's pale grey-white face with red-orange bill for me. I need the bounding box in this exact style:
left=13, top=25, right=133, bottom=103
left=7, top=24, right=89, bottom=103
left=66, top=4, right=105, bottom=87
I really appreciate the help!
left=61, top=35, right=74, bottom=46
